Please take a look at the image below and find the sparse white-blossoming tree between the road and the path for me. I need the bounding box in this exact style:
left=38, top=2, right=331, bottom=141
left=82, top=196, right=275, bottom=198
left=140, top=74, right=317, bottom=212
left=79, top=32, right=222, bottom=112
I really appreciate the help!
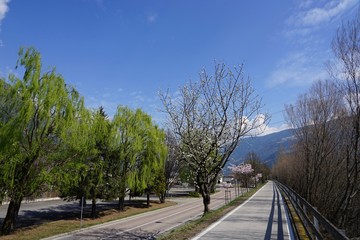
left=160, top=64, right=269, bottom=214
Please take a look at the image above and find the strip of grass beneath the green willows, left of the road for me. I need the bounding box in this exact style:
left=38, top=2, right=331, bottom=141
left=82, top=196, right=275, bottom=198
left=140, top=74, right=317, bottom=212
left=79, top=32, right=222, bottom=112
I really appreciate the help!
left=0, top=201, right=176, bottom=240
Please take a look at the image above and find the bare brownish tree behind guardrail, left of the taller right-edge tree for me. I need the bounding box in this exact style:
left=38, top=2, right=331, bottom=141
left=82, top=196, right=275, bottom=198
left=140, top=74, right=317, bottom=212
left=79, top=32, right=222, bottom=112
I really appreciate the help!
left=286, top=81, right=344, bottom=206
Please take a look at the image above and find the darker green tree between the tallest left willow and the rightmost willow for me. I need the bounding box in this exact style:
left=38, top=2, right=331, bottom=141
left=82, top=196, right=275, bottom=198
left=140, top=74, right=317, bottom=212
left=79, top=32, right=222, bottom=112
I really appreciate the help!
left=53, top=108, right=110, bottom=218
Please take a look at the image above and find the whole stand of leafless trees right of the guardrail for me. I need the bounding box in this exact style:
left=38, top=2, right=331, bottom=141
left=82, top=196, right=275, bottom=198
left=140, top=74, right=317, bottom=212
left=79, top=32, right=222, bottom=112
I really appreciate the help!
left=273, top=15, right=360, bottom=237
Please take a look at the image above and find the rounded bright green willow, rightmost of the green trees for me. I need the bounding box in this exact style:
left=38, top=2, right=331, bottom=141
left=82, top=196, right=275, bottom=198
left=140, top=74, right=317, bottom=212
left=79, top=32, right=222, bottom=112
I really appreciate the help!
left=107, top=106, right=166, bottom=210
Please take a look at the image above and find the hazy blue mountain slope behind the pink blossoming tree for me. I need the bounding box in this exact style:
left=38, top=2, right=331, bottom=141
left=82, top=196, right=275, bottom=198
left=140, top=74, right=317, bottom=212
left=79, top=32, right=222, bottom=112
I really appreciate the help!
left=224, top=129, right=295, bottom=171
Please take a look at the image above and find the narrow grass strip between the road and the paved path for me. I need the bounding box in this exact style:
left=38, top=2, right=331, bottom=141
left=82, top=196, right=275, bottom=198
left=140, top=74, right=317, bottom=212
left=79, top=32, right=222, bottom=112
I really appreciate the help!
left=156, top=184, right=265, bottom=240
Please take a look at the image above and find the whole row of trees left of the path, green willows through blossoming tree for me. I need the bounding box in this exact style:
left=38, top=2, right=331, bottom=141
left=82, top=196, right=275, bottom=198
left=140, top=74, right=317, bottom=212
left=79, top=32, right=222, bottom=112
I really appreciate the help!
left=0, top=48, right=269, bottom=234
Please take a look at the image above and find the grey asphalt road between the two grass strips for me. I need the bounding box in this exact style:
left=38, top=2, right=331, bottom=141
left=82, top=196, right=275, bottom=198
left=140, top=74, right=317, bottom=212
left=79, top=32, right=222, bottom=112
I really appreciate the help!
left=42, top=189, right=239, bottom=240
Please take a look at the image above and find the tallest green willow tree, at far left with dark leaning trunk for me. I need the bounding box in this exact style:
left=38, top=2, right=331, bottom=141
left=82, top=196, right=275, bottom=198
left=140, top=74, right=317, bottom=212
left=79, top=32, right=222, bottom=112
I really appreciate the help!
left=0, top=48, right=83, bottom=234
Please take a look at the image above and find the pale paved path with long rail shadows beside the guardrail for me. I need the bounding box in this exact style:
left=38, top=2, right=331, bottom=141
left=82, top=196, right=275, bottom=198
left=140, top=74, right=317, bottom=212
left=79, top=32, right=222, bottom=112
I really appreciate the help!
left=193, top=182, right=292, bottom=240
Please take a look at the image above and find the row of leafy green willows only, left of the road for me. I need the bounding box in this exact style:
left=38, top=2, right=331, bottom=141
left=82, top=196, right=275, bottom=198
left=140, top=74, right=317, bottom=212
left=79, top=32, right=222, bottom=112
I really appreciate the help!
left=0, top=48, right=167, bottom=234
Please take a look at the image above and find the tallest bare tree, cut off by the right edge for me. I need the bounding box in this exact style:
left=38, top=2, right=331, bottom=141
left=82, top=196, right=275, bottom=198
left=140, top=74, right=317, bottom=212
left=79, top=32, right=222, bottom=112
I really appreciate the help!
left=329, top=12, right=360, bottom=234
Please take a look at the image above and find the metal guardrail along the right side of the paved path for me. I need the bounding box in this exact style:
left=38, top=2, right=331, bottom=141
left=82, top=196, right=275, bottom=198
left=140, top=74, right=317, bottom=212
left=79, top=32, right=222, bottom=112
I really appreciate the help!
left=275, top=181, right=349, bottom=240
